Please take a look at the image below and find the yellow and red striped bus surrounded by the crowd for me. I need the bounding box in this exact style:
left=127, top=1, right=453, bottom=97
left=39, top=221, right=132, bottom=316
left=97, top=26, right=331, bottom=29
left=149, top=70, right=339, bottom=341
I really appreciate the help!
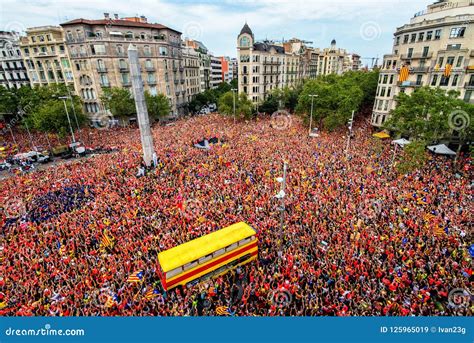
left=158, top=222, right=258, bottom=291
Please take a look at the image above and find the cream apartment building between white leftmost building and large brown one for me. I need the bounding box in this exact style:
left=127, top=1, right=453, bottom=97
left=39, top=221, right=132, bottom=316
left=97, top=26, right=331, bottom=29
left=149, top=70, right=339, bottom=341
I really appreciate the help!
left=20, top=26, right=74, bottom=88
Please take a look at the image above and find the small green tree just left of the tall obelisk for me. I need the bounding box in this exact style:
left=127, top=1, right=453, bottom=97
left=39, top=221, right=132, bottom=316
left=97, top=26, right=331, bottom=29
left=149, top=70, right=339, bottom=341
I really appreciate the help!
left=100, top=87, right=137, bottom=119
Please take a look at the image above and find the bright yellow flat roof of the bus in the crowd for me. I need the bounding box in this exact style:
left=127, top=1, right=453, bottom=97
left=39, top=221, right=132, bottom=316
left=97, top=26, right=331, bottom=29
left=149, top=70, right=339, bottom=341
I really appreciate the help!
left=158, top=222, right=255, bottom=273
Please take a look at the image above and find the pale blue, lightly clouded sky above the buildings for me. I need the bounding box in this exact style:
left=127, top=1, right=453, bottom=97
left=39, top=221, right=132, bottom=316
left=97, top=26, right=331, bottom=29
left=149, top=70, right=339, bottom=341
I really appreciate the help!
left=0, top=0, right=434, bottom=65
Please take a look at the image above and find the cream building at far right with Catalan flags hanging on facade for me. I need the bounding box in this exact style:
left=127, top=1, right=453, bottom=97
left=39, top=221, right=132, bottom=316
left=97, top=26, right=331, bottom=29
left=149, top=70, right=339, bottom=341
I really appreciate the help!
left=371, top=0, right=474, bottom=127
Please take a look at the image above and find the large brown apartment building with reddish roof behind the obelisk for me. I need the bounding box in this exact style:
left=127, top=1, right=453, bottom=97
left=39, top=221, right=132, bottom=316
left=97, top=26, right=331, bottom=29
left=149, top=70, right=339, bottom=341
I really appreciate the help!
left=61, top=13, right=187, bottom=115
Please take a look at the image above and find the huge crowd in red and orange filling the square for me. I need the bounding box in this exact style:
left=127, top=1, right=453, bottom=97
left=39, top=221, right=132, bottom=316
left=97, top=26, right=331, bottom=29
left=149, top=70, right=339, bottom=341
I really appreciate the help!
left=0, top=115, right=474, bottom=316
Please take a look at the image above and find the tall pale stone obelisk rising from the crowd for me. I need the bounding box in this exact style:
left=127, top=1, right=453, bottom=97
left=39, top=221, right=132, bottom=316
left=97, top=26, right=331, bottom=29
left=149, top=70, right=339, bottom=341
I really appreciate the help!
left=128, top=44, right=154, bottom=167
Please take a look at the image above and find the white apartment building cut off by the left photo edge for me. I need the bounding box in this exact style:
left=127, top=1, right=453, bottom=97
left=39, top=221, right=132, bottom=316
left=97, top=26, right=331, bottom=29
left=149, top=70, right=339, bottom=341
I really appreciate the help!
left=0, top=31, right=30, bottom=89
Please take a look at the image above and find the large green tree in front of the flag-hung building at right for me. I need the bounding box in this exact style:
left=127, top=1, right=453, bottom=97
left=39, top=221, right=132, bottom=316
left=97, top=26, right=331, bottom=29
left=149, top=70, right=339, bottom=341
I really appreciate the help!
left=384, top=86, right=474, bottom=142
